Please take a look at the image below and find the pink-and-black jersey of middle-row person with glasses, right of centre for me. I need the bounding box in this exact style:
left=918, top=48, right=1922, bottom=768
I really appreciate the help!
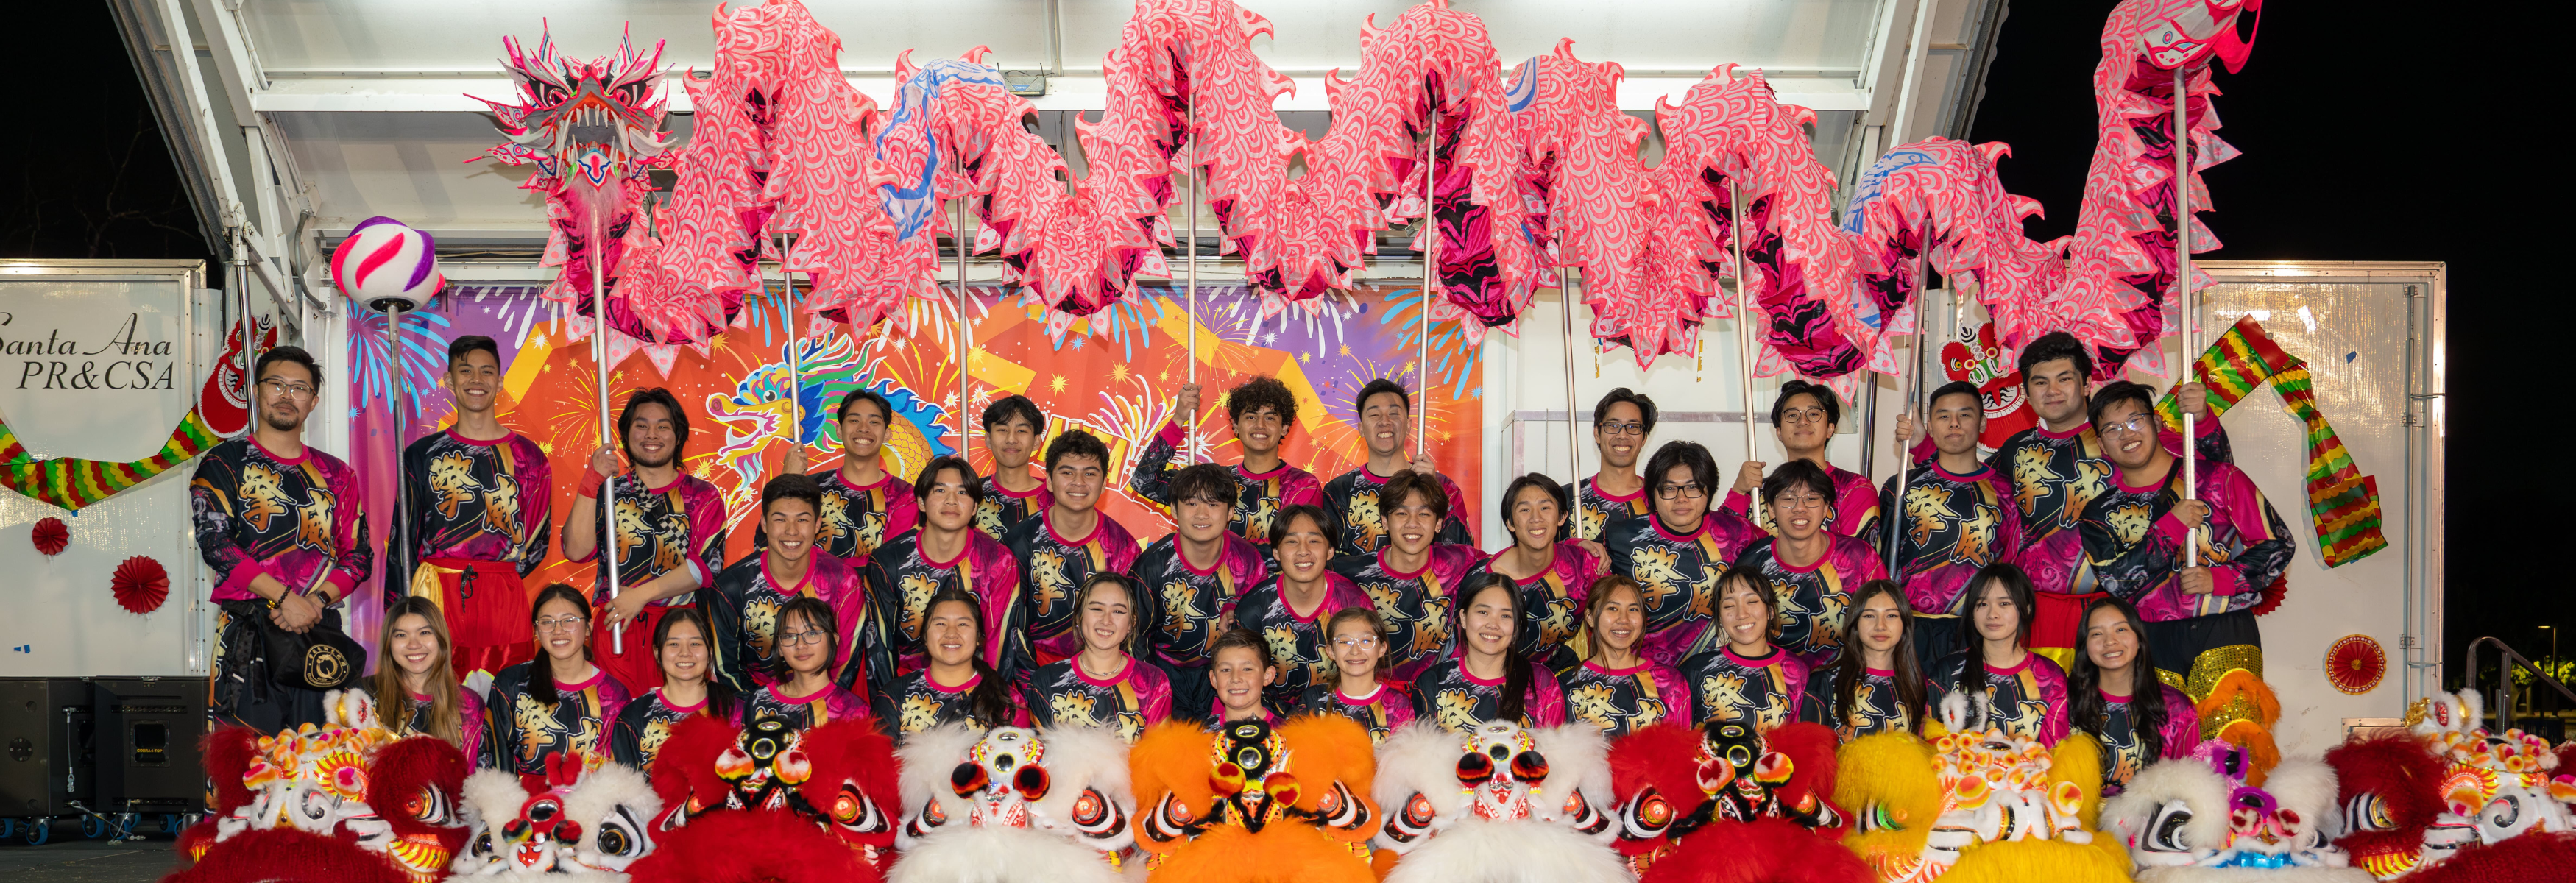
left=1602, top=510, right=1765, bottom=664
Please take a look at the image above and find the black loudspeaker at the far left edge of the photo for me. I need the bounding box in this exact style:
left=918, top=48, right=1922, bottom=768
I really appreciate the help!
left=0, top=677, right=93, bottom=819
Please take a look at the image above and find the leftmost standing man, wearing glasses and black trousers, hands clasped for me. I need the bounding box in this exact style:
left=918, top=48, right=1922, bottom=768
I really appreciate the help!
left=188, top=347, right=376, bottom=734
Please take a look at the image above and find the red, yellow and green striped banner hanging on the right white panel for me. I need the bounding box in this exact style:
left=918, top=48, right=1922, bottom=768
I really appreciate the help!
left=2156, top=316, right=2388, bottom=567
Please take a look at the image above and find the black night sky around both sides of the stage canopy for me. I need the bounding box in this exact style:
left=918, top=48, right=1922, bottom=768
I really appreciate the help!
left=0, top=0, right=2535, bottom=682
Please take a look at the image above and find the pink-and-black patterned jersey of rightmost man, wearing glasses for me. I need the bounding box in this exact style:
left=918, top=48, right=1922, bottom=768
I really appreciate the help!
left=2069, top=464, right=2298, bottom=623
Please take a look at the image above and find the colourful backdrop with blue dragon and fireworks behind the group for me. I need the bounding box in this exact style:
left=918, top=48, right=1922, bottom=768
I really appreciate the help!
left=350, top=286, right=1484, bottom=602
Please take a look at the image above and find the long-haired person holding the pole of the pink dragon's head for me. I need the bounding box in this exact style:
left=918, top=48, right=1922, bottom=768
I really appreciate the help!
left=565, top=386, right=724, bottom=695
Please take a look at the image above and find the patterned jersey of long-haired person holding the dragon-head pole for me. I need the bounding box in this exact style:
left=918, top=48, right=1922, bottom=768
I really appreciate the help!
left=572, top=471, right=724, bottom=608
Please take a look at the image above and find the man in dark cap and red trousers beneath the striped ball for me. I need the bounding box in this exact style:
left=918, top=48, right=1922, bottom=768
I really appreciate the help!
left=384, top=335, right=554, bottom=677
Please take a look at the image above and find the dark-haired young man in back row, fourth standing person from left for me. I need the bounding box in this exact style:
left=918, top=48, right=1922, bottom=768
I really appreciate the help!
left=778, top=389, right=920, bottom=561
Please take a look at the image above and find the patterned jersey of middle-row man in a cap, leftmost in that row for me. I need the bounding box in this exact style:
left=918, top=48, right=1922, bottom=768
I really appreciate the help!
left=698, top=548, right=894, bottom=692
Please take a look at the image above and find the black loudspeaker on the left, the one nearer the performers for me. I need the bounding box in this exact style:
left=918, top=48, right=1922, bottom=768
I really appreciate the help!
left=91, top=677, right=206, bottom=814
